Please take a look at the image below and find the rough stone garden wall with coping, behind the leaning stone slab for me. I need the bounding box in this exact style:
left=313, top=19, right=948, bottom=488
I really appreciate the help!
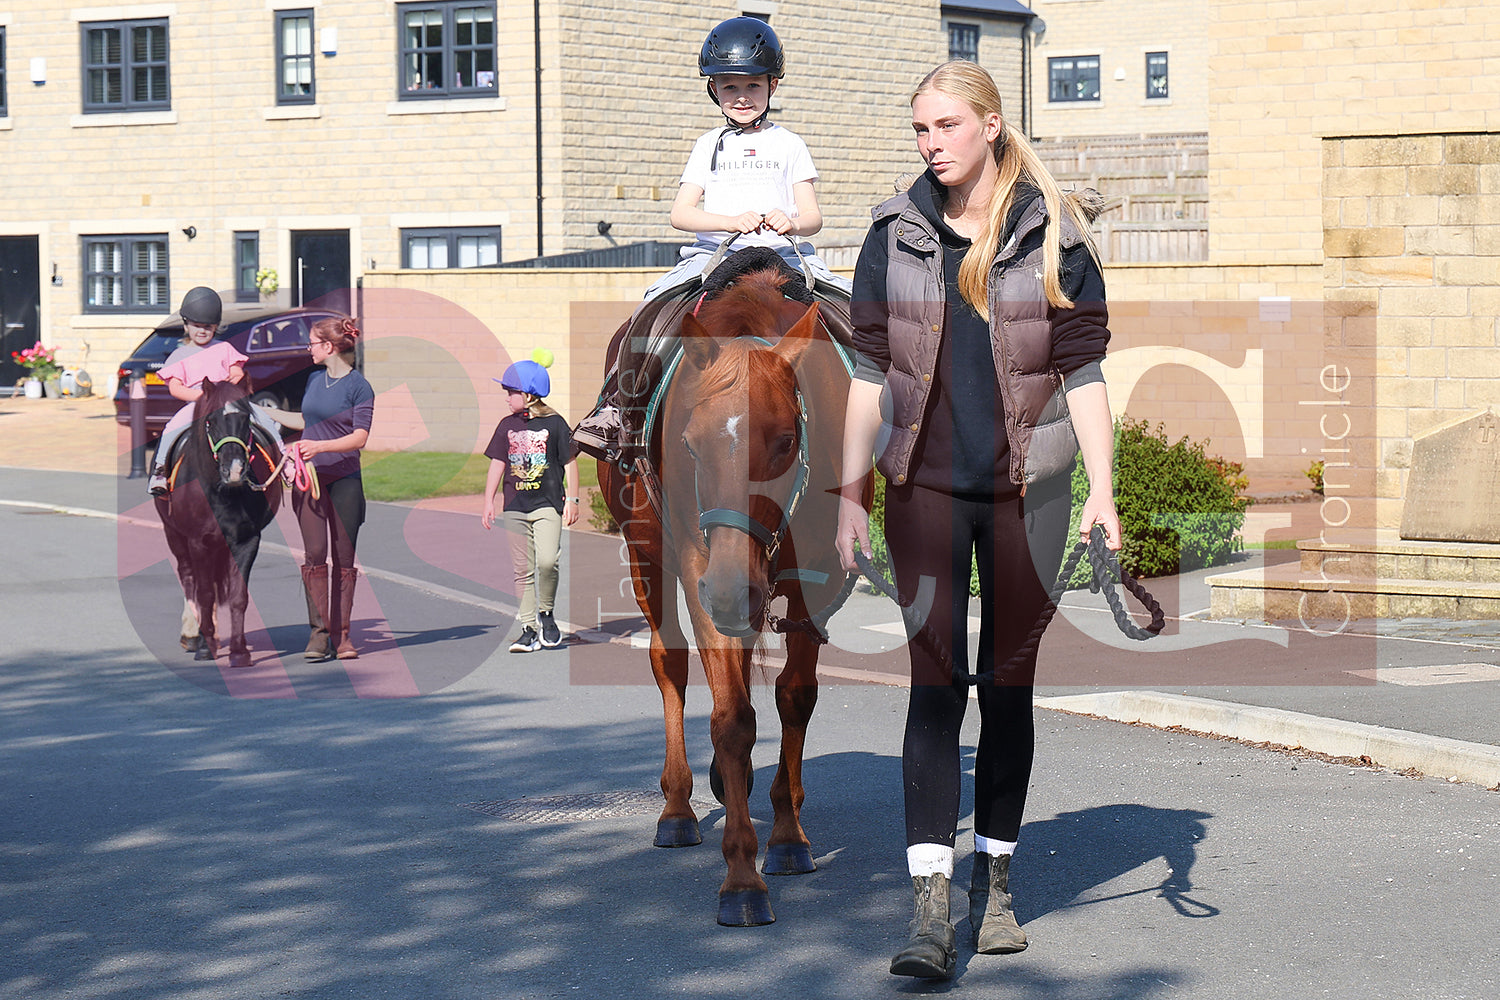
left=1323, top=132, right=1500, bottom=528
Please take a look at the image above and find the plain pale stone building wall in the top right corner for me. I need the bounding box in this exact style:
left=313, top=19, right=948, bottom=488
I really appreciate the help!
left=1208, top=0, right=1500, bottom=264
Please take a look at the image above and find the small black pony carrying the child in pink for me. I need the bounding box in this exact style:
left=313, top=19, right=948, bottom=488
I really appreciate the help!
left=156, top=382, right=282, bottom=667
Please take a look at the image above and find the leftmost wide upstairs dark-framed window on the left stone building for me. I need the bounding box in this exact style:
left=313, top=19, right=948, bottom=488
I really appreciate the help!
left=80, top=18, right=173, bottom=112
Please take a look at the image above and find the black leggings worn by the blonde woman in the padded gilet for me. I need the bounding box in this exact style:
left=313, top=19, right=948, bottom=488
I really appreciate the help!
left=885, top=475, right=1071, bottom=847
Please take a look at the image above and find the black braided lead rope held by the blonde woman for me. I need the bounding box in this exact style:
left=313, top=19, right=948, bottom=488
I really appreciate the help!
left=840, top=525, right=1167, bottom=685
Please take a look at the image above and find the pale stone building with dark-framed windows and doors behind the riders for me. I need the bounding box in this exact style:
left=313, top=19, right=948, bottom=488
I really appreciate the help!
left=0, top=0, right=945, bottom=385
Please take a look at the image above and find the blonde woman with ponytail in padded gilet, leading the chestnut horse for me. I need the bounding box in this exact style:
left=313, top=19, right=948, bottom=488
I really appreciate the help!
left=837, top=61, right=1121, bottom=979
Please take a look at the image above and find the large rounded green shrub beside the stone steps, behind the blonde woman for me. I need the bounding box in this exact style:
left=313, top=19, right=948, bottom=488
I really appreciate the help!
left=1068, top=417, right=1250, bottom=586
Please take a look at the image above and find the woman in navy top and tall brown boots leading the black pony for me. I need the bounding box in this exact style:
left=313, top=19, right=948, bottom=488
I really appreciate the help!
left=258, top=318, right=375, bottom=660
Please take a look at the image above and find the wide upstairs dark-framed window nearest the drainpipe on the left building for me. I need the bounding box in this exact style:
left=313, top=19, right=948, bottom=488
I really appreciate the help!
left=396, top=0, right=497, bottom=100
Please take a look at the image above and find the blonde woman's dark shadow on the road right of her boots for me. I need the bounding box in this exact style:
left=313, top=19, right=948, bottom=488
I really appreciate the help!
left=1016, top=802, right=1220, bottom=924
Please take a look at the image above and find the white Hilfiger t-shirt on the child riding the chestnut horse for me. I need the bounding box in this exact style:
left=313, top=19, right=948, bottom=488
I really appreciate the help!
left=681, top=121, right=818, bottom=249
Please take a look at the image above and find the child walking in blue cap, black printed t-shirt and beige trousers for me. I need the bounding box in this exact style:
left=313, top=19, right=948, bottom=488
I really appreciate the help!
left=480, top=351, right=578, bottom=652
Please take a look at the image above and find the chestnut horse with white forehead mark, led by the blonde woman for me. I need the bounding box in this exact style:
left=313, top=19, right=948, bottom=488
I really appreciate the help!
left=599, top=270, right=851, bottom=927
